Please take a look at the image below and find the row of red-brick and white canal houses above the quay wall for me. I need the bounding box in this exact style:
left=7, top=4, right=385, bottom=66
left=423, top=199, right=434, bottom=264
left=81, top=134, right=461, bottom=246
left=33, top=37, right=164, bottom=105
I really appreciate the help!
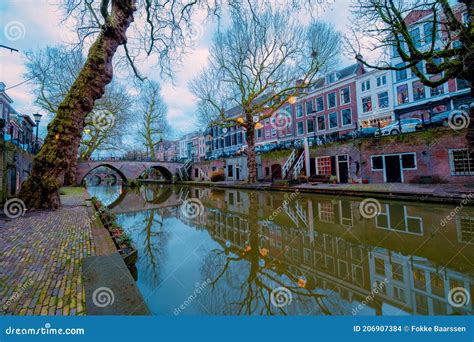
left=200, top=6, right=472, bottom=158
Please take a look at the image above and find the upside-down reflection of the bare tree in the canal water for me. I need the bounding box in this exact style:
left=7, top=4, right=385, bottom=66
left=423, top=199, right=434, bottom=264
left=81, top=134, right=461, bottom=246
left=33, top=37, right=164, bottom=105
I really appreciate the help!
left=201, top=194, right=330, bottom=315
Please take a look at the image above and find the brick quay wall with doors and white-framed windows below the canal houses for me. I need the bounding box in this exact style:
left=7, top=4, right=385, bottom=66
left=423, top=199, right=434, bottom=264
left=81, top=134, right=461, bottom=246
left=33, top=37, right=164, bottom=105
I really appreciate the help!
left=191, top=127, right=474, bottom=185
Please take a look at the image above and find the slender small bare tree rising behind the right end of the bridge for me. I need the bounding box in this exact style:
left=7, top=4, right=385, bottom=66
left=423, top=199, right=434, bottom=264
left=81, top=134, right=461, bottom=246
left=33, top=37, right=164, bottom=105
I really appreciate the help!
left=138, top=81, right=169, bottom=160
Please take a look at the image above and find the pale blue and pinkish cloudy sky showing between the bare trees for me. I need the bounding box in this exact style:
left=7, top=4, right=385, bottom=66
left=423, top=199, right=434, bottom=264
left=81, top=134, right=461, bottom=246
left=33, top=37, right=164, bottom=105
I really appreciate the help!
left=0, top=0, right=351, bottom=140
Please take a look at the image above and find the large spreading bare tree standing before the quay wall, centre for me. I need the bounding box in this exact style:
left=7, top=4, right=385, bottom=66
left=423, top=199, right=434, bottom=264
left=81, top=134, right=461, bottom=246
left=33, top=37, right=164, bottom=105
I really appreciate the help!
left=190, top=5, right=340, bottom=183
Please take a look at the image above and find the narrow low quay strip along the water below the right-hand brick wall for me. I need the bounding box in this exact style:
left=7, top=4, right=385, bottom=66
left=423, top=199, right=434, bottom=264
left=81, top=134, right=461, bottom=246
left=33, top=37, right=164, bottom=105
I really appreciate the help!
left=177, top=181, right=474, bottom=206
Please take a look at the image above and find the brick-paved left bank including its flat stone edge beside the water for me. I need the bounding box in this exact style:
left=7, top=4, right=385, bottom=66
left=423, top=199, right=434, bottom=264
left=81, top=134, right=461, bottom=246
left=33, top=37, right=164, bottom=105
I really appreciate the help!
left=0, top=188, right=149, bottom=315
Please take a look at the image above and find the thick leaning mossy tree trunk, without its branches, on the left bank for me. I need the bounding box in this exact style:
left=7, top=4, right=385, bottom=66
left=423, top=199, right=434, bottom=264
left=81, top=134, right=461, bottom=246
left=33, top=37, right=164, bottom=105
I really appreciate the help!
left=19, top=0, right=136, bottom=208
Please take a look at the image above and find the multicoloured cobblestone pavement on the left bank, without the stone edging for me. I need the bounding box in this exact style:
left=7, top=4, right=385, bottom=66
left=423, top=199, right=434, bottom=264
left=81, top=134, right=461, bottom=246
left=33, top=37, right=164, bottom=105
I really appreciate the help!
left=0, top=190, right=95, bottom=315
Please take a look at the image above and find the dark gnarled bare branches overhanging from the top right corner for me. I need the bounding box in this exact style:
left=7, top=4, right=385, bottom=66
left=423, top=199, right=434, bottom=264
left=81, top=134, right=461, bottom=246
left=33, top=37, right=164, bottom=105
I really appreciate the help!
left=348, top=0, right=474, bottom=150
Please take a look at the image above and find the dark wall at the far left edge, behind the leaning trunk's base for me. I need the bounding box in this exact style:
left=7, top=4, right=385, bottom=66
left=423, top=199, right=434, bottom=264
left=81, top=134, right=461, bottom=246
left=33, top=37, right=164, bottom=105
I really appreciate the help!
left=0, top=139, right=34, bottom=203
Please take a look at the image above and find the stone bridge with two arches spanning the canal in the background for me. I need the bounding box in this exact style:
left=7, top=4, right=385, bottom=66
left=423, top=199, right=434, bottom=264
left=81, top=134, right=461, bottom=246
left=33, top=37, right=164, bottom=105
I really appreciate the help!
left=76, top=160, right=184, bottom=185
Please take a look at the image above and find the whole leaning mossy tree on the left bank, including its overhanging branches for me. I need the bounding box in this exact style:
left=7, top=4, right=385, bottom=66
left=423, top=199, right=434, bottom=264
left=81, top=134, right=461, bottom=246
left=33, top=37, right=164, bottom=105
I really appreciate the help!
left=19, top=0, right=330, bottom=208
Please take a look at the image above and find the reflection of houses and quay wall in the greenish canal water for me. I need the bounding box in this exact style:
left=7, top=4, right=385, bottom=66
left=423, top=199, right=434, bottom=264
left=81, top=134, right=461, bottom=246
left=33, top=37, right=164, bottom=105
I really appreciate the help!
left=176, top=188, right=473, bottom=314
